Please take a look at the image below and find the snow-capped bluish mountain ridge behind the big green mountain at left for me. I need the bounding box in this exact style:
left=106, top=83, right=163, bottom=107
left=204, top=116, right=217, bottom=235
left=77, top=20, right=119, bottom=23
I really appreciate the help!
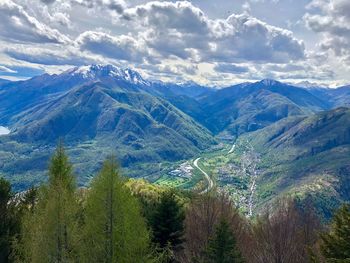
left=0, top=65, right=147, bottom=125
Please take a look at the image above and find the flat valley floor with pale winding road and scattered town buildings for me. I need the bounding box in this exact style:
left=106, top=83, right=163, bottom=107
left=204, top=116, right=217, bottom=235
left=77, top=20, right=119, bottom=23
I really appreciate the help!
left=155, top=140, right=259, bottom=216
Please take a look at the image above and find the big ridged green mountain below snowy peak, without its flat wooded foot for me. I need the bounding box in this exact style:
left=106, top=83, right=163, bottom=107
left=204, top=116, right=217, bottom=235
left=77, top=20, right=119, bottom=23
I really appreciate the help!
left=11, top=82, right=213, bottom=155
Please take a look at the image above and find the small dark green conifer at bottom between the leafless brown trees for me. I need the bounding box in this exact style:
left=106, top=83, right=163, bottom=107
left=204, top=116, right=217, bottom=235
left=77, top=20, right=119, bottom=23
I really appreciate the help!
left=206, top=219, right=244, bottom=263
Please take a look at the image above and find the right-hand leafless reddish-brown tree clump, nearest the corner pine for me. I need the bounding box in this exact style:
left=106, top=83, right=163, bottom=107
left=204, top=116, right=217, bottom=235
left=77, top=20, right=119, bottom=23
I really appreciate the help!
left=251, top=199, right=318, bottom=263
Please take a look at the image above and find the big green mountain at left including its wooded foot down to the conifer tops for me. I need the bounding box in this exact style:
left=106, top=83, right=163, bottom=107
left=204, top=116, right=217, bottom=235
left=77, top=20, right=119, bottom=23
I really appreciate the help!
left=0, top=83, right=216, bottom=190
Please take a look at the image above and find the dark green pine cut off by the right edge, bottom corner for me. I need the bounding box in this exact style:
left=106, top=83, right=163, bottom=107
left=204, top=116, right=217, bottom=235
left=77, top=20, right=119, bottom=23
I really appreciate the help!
left=321, top=204, right=350, bottom=263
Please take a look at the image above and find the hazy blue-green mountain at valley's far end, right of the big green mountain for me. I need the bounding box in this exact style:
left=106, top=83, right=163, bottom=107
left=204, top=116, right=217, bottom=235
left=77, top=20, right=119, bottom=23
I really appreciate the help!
left=191, top=79, right=331, bottom=137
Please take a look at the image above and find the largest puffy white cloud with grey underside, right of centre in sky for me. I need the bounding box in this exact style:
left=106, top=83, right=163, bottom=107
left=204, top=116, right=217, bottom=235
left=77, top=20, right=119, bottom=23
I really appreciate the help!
left=119, top=1, right=304, bottom=63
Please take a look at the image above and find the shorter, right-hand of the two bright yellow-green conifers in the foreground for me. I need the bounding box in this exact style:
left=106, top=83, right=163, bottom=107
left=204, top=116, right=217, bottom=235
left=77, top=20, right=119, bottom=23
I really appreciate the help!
left=81, top=157, right=150, bottom=263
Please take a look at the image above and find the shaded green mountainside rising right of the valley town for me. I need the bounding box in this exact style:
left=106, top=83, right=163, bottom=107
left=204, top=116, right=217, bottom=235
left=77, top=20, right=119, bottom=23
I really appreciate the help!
left=240, top=107, right=350, bottom=219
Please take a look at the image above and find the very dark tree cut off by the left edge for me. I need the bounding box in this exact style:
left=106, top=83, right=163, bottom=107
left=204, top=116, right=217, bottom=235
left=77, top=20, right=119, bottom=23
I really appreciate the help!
left=0, top=178, right=19, bottom=263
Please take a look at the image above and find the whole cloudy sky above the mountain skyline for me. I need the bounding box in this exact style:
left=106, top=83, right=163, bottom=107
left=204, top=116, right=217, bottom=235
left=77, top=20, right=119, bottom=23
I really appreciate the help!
left=0, top=0, right=350, bottom=86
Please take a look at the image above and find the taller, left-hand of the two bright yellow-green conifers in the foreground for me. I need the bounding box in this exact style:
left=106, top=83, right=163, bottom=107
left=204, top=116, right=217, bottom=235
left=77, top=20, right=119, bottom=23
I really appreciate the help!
left=18, top=144, right=79, bottom=263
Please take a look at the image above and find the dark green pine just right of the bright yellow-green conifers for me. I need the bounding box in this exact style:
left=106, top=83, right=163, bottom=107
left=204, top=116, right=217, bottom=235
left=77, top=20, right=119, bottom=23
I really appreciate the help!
left=151, top=191, right=185, bottom=251
